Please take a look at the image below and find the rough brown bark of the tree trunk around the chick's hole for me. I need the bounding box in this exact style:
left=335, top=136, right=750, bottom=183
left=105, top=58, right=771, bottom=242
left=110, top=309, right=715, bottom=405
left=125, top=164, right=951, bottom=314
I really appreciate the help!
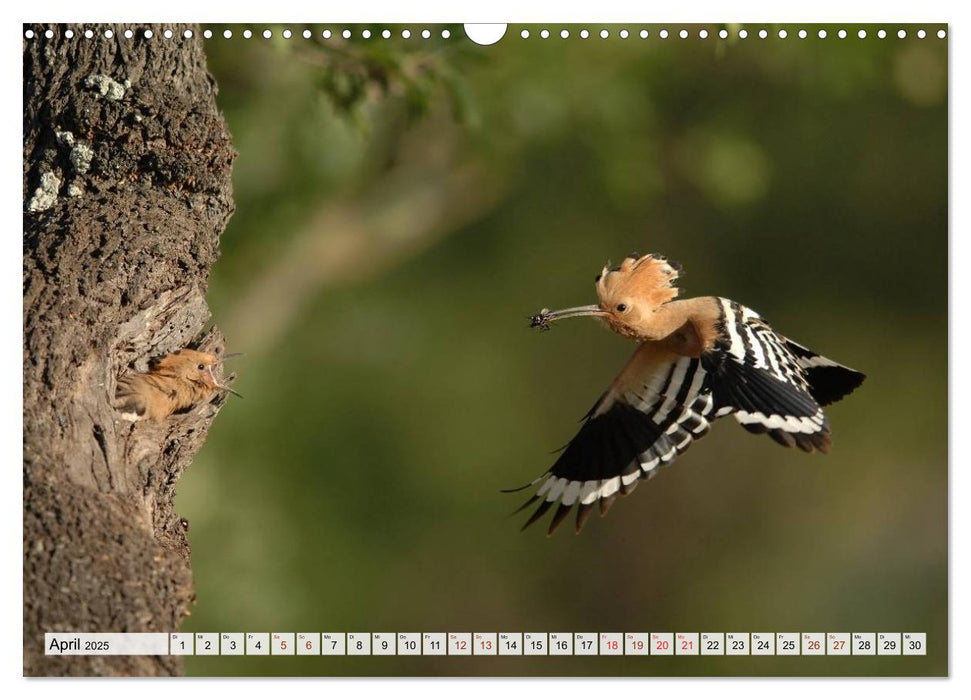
left=23, top=25, right=235, bottom=675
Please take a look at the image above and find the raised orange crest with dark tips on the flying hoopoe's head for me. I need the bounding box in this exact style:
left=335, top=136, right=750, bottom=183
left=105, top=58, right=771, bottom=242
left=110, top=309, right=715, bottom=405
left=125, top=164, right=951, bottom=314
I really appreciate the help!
left=597, top=253, right=681, bottom=309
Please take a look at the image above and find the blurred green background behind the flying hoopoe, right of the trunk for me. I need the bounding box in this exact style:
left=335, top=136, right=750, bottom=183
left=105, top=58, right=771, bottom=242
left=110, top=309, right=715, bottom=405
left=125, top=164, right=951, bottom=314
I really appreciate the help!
left=177, top=25, right=948, bottom=675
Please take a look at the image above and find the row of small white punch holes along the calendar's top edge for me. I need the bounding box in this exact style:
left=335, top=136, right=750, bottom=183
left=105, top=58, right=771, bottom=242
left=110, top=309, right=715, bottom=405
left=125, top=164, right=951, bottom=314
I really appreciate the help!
left=24, top=29, right=947, bottom=39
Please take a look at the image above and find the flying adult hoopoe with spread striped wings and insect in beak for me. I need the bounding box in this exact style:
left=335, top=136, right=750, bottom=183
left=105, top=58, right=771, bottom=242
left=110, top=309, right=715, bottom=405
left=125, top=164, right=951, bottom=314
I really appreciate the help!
left=513, top=254, right=865, bottom=534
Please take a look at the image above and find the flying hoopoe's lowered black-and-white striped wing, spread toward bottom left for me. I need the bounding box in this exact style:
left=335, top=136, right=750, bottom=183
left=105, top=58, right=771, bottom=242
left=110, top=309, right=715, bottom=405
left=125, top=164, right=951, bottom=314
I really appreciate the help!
left=520, top=344, right=714, bottom=534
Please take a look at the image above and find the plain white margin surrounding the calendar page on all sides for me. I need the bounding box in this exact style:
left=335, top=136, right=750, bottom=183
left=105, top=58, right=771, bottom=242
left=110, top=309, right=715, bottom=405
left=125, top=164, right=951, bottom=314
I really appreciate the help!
left=0, top=0, right=971, bottom=700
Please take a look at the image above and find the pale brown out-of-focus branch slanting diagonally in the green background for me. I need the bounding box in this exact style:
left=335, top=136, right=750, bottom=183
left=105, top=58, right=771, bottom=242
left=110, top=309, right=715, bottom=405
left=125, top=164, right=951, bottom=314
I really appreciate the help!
left=226, top=157, right=505, bottom=354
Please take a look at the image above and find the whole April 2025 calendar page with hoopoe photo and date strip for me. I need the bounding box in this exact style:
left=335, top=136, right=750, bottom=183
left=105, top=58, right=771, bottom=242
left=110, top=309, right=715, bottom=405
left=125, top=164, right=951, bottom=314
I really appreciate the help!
left=22, top=19, right=949, bottom=677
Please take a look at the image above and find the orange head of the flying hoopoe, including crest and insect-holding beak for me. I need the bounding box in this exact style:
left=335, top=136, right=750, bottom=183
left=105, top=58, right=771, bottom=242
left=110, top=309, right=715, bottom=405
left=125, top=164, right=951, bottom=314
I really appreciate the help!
left=531, top=254, right=681, bottom=337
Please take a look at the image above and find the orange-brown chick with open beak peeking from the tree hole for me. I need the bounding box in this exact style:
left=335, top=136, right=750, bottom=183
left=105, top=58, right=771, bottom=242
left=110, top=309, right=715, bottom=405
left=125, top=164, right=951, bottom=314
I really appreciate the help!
left=114, top=348, right=242, bottom=421
